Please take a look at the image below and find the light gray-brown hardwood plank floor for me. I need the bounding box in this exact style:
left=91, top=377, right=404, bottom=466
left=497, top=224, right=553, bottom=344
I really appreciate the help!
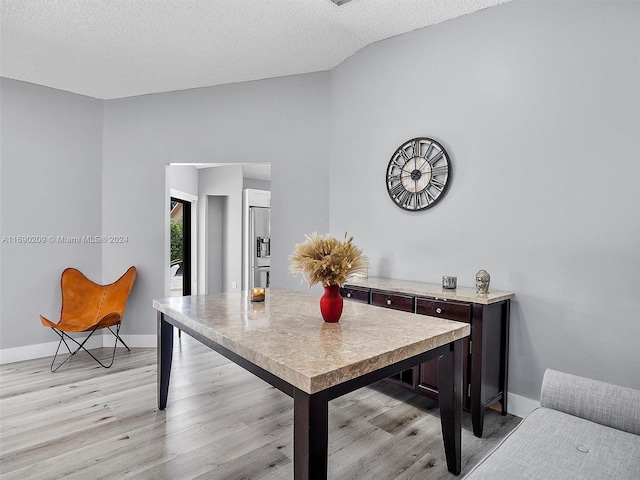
left=0, top=334, right=520, bottom=480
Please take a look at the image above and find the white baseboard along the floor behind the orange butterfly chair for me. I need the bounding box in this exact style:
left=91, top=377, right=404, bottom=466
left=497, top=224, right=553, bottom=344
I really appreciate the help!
left=0, top=334, right=157, bottom=365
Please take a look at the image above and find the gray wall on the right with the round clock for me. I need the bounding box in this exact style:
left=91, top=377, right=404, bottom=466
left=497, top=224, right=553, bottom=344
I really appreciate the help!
left=330, top=2, right=640, bottom=398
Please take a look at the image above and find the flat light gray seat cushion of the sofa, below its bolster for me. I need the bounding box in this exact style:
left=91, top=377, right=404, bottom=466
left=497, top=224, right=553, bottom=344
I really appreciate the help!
left=465, top=407, right=640, bottom=480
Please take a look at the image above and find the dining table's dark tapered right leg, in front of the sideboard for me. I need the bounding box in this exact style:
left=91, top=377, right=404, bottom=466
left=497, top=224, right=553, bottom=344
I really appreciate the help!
left=438, top=340, right=462, bottom=475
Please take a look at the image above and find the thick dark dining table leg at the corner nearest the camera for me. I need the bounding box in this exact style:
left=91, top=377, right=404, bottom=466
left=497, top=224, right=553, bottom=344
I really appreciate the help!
left=293, top=388, right=329, bottom=480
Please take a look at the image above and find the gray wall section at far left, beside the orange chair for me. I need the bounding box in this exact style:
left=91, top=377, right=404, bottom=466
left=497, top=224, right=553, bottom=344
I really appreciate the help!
left=0, top=78, right=102, bottom=354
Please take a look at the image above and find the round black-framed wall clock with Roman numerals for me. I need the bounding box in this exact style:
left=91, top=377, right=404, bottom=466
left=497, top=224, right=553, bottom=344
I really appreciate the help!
left=387, top=137, right=451, bottom=211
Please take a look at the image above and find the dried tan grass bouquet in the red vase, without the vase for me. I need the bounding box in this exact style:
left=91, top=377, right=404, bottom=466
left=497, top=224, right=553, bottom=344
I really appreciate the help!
left=289, top=233, right=369, bottom=288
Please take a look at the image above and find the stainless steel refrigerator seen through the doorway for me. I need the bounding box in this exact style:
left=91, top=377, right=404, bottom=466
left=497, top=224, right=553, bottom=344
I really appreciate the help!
left=249, top=207, right=271, bottom=289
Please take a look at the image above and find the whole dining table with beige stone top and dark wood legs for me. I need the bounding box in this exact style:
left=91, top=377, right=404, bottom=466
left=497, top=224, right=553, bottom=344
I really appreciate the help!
left=153, top=288, right=470, bottom=480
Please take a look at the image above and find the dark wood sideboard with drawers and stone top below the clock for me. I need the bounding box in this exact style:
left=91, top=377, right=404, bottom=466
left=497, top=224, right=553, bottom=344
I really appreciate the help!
left=340, top=278, right=515, bottom=437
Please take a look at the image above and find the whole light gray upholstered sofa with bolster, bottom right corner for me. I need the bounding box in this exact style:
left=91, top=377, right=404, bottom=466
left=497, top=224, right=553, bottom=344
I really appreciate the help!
left=463, top=370, right=640, bottom=480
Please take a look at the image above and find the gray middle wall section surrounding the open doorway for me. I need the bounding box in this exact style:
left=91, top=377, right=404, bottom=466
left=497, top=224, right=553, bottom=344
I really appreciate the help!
left=103, top=73, right=330, bottom=335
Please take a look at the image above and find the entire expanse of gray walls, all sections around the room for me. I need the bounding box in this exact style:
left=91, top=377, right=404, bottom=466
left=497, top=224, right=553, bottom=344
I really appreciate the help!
left=0, top=2, right=640, bottom=406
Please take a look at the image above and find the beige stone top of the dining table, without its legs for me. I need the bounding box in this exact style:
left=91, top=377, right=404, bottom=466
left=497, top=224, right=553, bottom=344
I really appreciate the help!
left=153, top=288, right=470, bottom=394
